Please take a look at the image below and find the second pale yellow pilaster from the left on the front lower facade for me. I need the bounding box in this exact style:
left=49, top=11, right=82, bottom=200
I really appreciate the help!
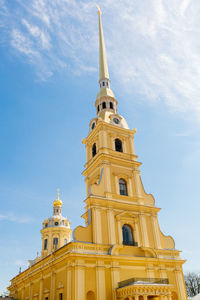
left=96, top=262, right=106, bottom=300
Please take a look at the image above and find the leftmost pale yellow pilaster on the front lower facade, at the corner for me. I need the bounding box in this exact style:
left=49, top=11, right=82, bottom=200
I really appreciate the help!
left=74, top=261, right=85, bottom=300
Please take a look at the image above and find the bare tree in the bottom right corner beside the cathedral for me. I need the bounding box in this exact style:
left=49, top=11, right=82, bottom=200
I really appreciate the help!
left=185, top=273, right=200, bottom=297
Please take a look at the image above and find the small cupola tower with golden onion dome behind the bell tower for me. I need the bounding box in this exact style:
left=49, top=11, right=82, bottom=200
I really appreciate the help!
left=41, top=189, right=72, bottom=258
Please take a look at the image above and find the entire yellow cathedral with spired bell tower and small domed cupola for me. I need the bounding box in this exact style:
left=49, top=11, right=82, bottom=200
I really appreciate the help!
left=8, top=9, right=187, bottom=300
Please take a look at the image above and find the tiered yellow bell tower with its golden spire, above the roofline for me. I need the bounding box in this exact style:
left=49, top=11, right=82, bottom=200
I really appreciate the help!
left=74, top=9, right=175, bottom=249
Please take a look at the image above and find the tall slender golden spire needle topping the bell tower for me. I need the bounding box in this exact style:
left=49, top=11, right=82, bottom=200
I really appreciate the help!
left=97, top=5, right=109, bottom=82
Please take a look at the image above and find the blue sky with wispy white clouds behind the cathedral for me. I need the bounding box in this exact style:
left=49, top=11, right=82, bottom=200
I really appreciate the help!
left=0, top=0, right=200, bottom=293
